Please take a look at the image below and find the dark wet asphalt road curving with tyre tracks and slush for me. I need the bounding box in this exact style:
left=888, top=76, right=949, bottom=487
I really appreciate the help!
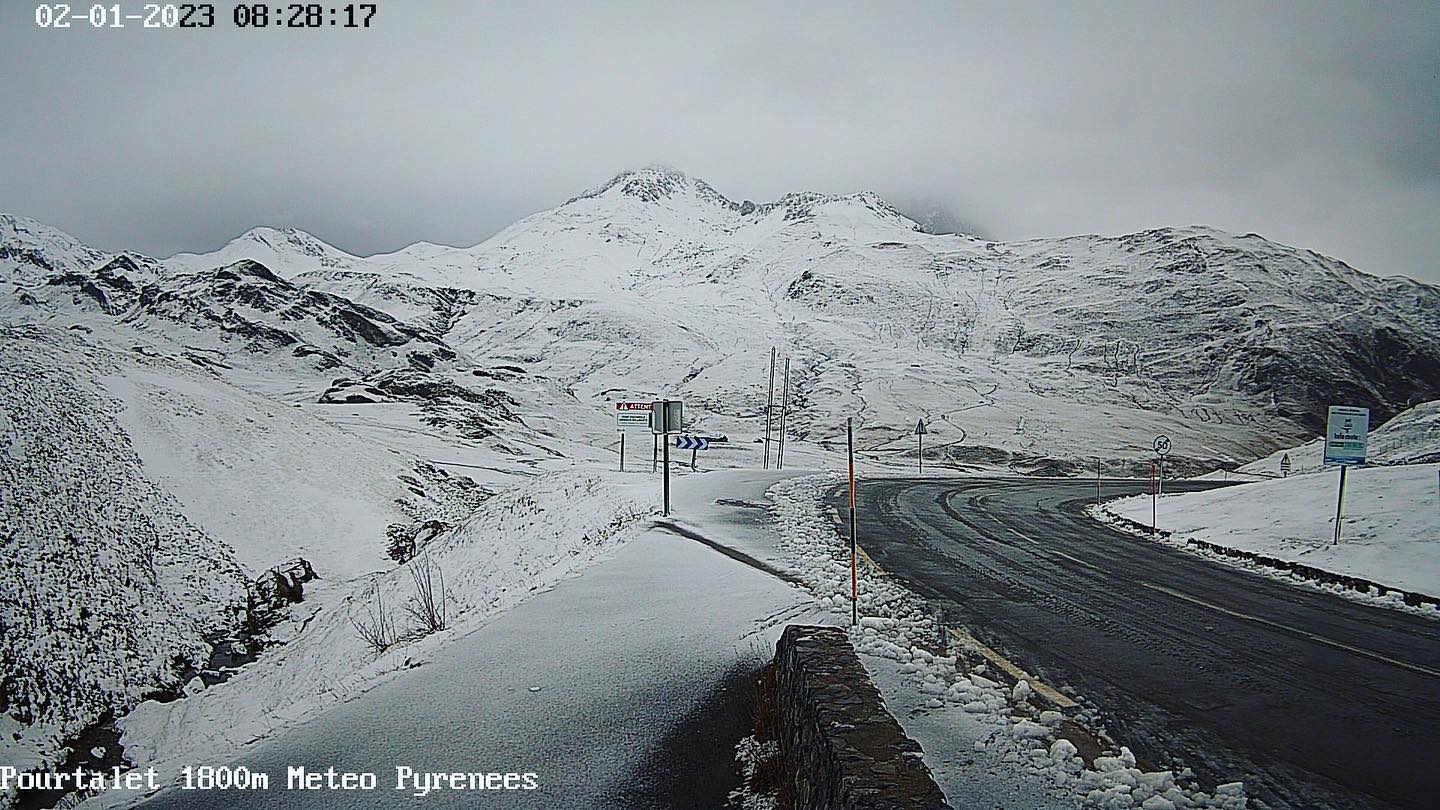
left=832, top=479, right=1440, bottom=807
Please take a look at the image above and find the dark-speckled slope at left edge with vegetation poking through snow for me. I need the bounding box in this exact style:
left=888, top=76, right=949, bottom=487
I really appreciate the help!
left=0, top=329, right=245, bottom=765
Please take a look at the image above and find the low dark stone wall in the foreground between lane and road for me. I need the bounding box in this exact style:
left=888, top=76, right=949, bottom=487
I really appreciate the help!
left=775, top=624, right=950, bottom=810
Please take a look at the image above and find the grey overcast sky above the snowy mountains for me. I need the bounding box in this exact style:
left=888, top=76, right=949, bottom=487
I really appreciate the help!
left=0, top=0, right=1440, bottom=282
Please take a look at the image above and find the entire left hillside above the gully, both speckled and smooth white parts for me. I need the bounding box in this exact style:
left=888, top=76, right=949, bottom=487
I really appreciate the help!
left=0, top=326, right=484, bottom=784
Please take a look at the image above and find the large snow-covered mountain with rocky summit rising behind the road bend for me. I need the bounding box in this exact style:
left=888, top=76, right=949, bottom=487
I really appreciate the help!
left=171, top=169, right=1440, bottom=471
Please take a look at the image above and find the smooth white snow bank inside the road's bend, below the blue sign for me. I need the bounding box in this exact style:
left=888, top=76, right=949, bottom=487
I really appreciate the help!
left=1100, top=464, right=1440, bottom=595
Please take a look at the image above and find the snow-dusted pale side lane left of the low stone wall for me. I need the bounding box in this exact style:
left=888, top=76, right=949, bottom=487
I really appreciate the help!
left=120, top=474, right=815, bottom=809
